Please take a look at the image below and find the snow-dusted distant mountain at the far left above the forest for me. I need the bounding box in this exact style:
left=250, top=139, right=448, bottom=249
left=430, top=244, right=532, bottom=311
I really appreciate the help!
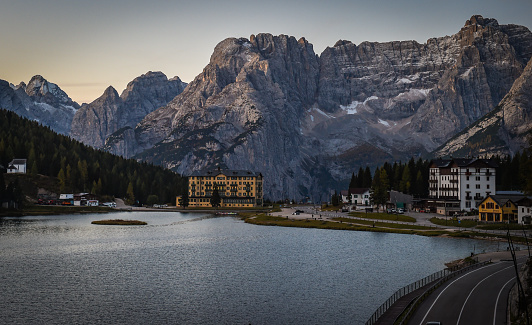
left=0, top=75, right=79, bottom=134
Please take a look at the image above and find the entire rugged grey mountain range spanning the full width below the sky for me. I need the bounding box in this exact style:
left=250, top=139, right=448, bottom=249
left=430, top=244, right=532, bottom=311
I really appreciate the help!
left=0, top=16, right=532, bottom=201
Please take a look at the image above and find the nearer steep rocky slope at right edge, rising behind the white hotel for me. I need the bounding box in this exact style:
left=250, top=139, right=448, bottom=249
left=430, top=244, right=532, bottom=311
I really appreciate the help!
left=434, top=54, right=532, bottom=156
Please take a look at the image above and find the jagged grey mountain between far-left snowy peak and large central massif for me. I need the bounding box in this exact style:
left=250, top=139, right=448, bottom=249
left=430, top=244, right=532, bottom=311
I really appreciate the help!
left=71, top=72, right=186, bottom=148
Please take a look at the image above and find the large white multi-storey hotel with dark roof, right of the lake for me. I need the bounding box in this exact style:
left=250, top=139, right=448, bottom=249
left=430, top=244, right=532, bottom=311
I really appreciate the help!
left=429, top=158, right=497, bottom=214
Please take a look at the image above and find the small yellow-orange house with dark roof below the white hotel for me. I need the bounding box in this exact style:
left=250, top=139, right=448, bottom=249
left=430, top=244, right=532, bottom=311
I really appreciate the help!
left=478, top=194, right=524, bottom=223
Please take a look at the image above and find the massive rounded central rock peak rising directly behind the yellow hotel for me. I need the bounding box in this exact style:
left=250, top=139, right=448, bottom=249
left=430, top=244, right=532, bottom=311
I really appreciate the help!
left=106, top=34, right=326, bottom=196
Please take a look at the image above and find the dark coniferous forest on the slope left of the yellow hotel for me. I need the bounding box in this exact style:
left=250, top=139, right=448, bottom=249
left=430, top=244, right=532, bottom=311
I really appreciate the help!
left=0, top=110, right=186, bottom=204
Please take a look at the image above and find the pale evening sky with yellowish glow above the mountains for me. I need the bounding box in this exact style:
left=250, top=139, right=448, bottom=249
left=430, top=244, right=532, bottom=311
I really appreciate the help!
left=0, top=0, right=532, bottom=104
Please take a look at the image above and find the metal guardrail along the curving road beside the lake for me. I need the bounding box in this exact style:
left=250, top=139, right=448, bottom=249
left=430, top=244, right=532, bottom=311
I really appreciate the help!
left=366, top=261, right=486, bottom=325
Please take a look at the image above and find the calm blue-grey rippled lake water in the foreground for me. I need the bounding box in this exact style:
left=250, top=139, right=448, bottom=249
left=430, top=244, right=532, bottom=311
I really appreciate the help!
left=0, top=212, right=497, bottom=324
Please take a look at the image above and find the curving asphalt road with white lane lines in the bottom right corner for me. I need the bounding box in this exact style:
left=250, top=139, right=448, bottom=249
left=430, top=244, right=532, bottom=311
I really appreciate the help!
left=408, top=258, right=526, bottom=325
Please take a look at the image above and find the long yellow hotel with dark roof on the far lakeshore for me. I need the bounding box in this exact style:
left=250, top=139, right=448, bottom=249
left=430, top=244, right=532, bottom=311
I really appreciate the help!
left=188, top=168, right=263, bottom=208
